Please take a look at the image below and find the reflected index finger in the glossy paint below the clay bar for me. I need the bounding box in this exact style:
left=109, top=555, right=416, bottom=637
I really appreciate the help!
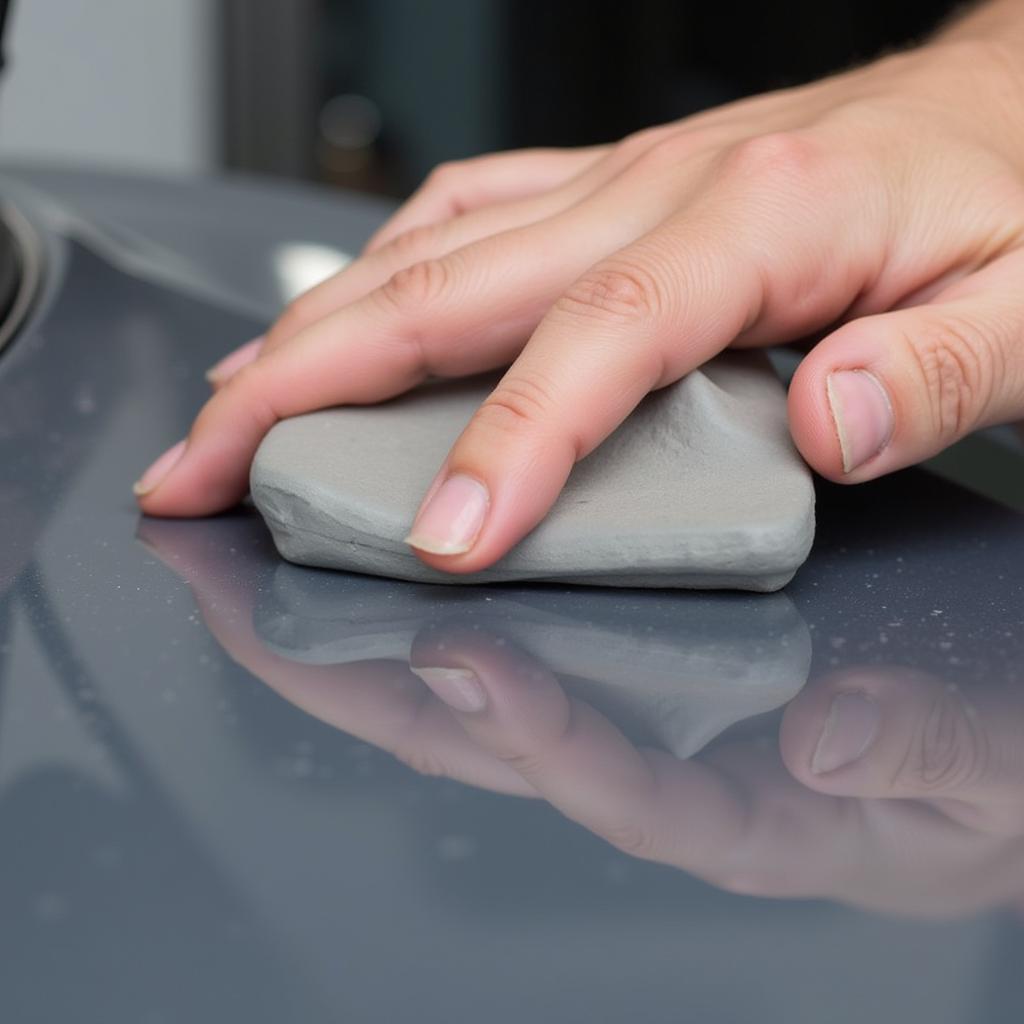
left=411, top=627, right=746, bottom=867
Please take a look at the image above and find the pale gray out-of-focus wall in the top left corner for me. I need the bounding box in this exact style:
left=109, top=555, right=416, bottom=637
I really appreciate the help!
left=0, top=0, right=219, bottom=173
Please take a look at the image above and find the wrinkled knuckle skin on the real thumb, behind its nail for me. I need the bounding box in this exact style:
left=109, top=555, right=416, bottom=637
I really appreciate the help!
left=900, top=318, right=998, bottom=441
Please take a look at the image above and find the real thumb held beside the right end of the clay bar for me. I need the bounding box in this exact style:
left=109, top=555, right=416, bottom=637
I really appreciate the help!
left=790, top=253, right=1024, bottom=483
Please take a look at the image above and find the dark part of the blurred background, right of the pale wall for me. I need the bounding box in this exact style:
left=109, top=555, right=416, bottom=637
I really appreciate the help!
left=220, top=0, right=957, bottom=196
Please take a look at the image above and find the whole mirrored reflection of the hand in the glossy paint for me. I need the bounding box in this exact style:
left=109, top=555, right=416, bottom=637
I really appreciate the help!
left=144, top=524, right=1024, bottom=916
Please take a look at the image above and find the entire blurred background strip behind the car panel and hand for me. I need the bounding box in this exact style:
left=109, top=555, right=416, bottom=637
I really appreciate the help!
left=0, top=0, right=954, bottom=197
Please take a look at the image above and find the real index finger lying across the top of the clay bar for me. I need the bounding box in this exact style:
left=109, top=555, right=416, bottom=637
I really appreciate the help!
left=409, top=133, right=866, bottom=573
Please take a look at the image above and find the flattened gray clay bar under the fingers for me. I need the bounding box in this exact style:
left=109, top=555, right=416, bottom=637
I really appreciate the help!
left=251, top=352, right=814, bottom=591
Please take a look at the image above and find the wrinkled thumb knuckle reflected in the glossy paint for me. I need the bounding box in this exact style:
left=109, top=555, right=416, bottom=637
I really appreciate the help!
left=893, top=693, right=991, bottom=793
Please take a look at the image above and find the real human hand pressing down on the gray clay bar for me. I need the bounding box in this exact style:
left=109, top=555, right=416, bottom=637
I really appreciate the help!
left=139, top=22, right=1024, bottom=572
